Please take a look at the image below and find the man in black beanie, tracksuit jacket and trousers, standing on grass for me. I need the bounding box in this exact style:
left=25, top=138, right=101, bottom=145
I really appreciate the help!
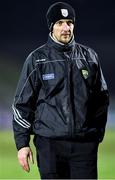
left=13, top=2, right=109, bottom=179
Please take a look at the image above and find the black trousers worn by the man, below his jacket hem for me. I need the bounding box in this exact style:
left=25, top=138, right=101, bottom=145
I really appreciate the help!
left=34, top=135, right=98, bottom=180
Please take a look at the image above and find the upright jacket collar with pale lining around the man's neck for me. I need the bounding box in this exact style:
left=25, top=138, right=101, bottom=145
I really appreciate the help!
left=47, top=33, right=75, bottom=52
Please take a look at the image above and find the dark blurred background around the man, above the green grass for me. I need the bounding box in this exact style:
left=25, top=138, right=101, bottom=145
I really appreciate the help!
left=0, top=0, right=115, bottom=129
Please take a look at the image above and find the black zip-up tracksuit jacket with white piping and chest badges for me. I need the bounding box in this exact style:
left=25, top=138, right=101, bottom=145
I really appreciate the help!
left=12, top=36, right=109, bottom=149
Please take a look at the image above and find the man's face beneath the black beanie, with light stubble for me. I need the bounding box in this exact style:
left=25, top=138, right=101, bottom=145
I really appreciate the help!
left=52, top=19, right=74, bottom=44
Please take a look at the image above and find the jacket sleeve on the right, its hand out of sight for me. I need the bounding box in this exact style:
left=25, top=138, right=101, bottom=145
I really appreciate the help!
left=93, top=53, right=109, bottom=142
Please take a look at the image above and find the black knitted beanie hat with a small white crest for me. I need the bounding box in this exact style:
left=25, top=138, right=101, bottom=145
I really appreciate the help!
left=46, top=2, right=75, bottom=31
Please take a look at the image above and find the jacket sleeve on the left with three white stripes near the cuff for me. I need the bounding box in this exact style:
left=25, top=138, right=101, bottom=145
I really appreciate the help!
left=12, top=55, right=40, bottom=150
